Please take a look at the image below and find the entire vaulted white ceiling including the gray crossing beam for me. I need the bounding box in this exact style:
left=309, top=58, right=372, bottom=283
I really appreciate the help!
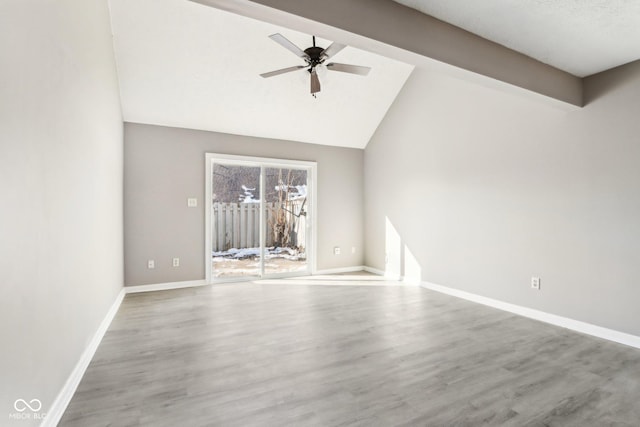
left=109, top=0, right=640, bottom=148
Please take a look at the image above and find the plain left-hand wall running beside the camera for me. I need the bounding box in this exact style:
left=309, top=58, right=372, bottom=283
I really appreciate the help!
left=0, top=0, right=123, bottom=426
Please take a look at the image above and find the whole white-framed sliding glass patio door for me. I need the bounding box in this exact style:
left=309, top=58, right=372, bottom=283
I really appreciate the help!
left=206, top=154, right=315, bottom=282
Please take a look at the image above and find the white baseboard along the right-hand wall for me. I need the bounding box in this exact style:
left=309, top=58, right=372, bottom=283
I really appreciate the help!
left=420, top=282, right=640, bottom=348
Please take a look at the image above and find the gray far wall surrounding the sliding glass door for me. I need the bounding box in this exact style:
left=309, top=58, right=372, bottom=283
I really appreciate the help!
left=124, top=123, right=364, bottom=285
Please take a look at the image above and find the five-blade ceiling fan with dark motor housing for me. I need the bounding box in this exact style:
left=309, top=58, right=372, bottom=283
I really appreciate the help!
left=260, top=33, right=371, bottom=97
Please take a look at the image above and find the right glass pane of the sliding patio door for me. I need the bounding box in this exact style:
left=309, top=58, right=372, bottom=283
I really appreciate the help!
left=264, top=167, right=309, bottom=275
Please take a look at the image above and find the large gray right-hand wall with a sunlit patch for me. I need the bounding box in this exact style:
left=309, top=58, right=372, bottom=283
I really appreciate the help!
left=365, top=62, right=640, bottom=335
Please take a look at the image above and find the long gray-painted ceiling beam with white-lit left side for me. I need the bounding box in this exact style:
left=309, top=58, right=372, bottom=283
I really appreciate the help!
left=192, top=0, right=583, bottom=107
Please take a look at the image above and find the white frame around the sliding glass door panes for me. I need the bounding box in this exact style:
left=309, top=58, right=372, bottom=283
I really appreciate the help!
left=204, top=153, right=318, bottom=284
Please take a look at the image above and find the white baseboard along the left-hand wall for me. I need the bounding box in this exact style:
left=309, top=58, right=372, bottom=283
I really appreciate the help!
left=40, top=289, right=125, bottom=427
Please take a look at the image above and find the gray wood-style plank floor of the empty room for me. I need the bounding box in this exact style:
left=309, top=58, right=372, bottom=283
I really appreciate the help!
left=60, top=276, right=640, bottom=427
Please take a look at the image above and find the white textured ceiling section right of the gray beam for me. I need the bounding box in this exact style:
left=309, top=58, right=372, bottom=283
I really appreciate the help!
left=395, top=0, right=640, bottom=77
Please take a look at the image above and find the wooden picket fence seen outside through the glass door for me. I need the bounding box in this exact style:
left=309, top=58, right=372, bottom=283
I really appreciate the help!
left=211, top=201, right=306, bottom=252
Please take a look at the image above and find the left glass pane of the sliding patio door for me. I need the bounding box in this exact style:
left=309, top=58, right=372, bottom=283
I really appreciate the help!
left=211, top=162, right=262, bottom=279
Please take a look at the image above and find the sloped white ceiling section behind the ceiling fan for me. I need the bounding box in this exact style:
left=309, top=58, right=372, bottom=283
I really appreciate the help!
left=109, top=0, right=413, bottom=148
